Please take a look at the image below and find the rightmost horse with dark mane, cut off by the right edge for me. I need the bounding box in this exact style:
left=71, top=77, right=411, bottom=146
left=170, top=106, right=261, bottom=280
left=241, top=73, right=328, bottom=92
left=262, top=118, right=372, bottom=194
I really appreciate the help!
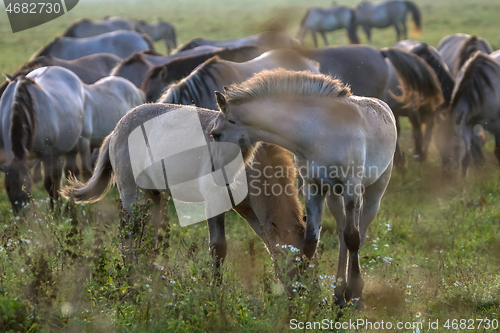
left=436, top=51, right=500, bottom=176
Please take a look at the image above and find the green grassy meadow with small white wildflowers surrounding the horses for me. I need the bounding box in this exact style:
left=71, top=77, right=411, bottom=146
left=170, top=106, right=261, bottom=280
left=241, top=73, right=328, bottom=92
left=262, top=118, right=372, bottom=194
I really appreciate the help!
left=0, top=0, right=500, bottom=333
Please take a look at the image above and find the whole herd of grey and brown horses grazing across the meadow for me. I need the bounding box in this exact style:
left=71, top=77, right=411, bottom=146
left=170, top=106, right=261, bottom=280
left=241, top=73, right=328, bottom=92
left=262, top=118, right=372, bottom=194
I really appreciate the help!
left=0, top=1, right=500, bottom=308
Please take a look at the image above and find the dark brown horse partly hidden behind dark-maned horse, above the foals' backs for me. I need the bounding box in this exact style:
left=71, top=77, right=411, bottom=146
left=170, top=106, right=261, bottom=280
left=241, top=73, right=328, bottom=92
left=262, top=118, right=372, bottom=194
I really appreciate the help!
left=142, top=46, right=266, bottom=102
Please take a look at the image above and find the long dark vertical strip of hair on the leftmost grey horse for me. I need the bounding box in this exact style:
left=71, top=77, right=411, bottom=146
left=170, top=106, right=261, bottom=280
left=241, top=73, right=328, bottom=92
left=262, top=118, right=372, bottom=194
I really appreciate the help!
left=10, top=75, right=36, bottom=160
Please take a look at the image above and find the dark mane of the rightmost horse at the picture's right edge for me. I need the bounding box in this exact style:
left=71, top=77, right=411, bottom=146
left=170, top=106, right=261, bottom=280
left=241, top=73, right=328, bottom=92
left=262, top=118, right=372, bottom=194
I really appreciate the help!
left=451, top=51, right=500, bottom=124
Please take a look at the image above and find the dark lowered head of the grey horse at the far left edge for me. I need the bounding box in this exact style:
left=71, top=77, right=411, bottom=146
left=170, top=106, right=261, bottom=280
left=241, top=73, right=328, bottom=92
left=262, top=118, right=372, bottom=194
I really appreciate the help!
left=3, top=159, right=32, bottom=213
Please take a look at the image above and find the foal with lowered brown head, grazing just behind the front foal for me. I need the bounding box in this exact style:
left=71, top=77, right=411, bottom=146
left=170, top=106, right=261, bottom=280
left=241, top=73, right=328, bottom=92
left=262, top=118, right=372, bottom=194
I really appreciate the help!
left=62, top=104, right=305, bottom=294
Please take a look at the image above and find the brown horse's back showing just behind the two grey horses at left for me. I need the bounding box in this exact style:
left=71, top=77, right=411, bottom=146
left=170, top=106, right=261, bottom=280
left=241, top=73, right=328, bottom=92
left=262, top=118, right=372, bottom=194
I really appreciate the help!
left=0, top=53, right=122, bottom=97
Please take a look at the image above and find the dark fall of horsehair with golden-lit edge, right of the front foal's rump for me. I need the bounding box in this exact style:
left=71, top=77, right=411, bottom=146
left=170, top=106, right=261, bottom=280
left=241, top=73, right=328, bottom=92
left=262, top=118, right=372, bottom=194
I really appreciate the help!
left=380, top=49, right=444, bottom=110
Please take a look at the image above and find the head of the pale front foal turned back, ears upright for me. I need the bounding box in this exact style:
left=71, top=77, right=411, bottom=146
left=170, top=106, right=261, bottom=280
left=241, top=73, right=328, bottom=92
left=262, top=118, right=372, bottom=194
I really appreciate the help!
left=212, top=91, right=256, bottom=161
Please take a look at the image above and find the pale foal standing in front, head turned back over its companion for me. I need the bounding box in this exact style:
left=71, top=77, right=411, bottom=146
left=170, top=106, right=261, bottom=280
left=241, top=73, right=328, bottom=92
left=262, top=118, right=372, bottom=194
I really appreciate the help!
left=212, top=69, right=397, bottom=309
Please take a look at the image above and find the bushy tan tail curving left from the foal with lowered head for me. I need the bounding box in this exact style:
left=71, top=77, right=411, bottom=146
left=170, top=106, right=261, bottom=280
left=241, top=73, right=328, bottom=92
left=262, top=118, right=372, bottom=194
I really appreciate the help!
left=61, top=132, right=114, bottom=203
